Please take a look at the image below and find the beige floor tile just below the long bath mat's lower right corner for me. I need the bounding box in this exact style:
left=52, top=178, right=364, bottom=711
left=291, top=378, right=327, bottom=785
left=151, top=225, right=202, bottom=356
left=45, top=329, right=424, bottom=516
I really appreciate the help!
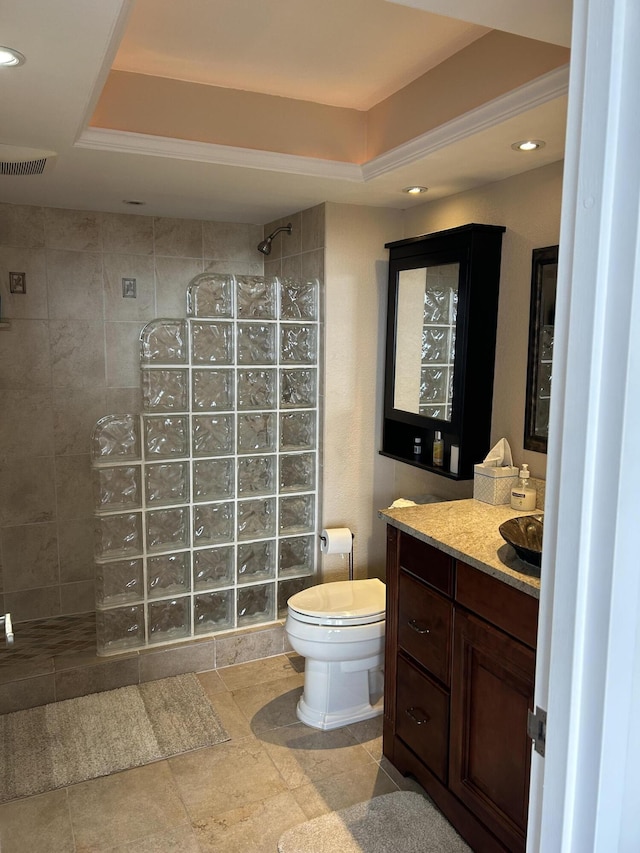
left=169, top=738, right=286, bottom=821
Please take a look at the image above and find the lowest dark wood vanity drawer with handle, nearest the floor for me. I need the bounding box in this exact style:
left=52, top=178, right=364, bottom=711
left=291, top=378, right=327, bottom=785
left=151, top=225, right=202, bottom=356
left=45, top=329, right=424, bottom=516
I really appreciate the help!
left=396, top=657, right=449, bottom=784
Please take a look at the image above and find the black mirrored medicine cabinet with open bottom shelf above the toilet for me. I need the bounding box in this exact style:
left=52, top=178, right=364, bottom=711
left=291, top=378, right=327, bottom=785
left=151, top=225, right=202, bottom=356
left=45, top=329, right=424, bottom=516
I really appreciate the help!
left=381, top=224, right=505, bottom=480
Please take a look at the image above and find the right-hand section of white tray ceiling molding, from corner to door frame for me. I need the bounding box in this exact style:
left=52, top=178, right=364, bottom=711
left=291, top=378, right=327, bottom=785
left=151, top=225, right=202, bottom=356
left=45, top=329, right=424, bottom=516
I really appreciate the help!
left=362, top=65, right=569, bottom=181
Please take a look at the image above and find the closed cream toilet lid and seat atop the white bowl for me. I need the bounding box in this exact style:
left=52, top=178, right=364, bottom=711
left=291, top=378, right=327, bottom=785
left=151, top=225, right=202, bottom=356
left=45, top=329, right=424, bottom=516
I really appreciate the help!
left=287, top=578, right=386, bottom=625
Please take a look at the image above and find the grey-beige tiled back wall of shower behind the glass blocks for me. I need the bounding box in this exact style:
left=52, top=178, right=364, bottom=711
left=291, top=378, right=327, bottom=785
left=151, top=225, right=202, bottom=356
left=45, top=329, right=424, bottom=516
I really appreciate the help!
left=0, top=204, right=268, bottom=621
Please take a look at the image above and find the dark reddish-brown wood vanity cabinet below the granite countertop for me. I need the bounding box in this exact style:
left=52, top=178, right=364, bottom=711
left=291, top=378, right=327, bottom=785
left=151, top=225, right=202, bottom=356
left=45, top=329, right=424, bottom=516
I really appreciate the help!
left=383, top=525, right=538, bottom=853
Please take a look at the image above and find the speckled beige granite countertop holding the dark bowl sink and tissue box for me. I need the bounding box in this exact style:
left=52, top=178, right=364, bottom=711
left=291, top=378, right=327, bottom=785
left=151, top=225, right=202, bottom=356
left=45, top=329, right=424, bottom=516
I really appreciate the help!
left=378, top=498, right=541, bottom=598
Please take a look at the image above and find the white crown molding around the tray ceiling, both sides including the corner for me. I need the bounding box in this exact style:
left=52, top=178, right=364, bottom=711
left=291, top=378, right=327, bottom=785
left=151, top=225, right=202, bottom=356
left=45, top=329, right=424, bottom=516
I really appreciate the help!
left=75, top=65, right=569, bottom=183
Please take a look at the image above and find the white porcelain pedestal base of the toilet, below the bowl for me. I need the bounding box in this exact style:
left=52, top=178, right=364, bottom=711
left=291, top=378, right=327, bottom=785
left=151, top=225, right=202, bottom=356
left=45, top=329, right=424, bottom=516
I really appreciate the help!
left=296, top=656, right=383, bottom=731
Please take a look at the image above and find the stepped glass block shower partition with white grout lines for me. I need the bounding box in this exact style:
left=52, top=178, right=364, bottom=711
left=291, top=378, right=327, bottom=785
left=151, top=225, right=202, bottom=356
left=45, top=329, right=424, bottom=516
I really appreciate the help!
left=92, top=273, right=320, bottom=655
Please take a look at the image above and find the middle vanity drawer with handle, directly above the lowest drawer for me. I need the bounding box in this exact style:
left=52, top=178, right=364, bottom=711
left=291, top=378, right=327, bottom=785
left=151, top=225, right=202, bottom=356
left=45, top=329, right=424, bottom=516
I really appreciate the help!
left=398, top=571, right=453, bottom=685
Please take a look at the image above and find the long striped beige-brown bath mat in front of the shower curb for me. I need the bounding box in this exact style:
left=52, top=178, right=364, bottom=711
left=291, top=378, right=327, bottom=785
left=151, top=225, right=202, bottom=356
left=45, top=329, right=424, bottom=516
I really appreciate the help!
left=0, top=673, right=229, bottom=802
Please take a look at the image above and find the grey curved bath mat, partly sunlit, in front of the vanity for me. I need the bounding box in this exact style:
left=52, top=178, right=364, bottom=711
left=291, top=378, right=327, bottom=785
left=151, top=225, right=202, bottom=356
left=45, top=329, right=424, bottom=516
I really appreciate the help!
left=278, top=791, right=471, bottom=853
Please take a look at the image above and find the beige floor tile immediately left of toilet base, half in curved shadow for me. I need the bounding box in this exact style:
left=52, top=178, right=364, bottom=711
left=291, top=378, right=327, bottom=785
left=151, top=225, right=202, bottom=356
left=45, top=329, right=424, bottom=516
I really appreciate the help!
left=233, top=673, right=304, bottom=735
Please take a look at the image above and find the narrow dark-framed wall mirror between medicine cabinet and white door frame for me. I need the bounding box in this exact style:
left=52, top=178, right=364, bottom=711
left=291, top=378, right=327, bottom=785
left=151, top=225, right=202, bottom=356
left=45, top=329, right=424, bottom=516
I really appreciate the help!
left=524, top=246, right=558, bottom=453
